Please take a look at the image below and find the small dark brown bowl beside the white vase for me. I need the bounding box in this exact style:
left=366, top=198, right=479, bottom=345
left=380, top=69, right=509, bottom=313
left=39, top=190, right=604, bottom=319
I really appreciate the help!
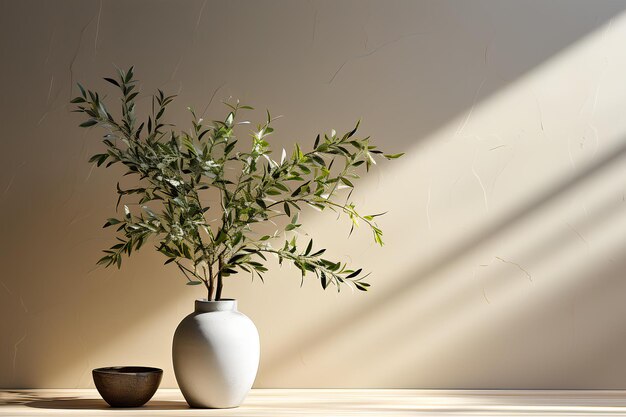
left=92, top=366, right=163, bottom=407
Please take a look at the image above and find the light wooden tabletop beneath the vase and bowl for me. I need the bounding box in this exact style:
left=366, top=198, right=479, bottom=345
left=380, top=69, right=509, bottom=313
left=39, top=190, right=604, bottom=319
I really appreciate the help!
left=0, top=389, right=626, bottom=417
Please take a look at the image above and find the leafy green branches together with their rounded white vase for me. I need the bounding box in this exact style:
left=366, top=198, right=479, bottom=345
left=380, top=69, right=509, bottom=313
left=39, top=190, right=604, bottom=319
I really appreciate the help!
left=72, top=67, right=402, bottom=408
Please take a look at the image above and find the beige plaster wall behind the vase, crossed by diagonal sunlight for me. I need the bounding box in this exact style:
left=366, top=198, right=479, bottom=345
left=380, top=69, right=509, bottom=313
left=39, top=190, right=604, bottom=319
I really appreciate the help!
left=0, top=0, right=626, bottom=388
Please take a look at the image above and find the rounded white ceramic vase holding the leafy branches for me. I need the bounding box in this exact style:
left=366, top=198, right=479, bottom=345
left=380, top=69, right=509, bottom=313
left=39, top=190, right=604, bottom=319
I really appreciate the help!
left=172, top=300, right=260, bottom=408
